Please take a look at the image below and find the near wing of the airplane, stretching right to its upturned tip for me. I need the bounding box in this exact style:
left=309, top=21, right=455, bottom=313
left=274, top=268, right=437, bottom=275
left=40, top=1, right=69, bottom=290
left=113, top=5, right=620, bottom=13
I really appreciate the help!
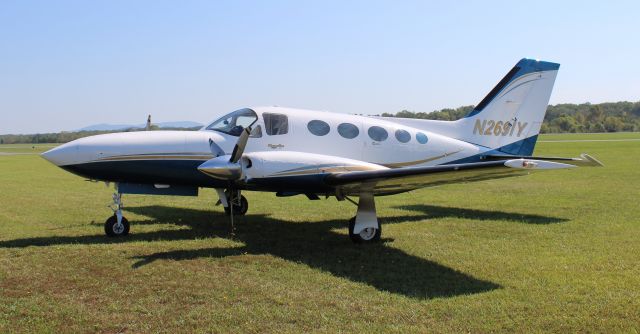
left=325, top=155, right=602, bottom=195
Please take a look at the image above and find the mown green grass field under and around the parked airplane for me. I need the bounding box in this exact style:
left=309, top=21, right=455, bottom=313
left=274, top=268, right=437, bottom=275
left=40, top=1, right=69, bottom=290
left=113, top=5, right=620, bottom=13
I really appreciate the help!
left=0, top=133, right=640, bottom=333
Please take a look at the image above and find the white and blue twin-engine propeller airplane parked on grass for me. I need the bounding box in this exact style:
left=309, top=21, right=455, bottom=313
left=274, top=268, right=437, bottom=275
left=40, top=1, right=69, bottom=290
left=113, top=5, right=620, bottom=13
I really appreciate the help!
left=42, top=58, right=602, bottom=243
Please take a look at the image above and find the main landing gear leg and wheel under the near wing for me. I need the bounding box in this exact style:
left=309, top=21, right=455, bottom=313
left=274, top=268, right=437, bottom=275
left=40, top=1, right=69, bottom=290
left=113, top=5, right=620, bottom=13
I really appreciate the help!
left=349, top=193, right=382, bottom=244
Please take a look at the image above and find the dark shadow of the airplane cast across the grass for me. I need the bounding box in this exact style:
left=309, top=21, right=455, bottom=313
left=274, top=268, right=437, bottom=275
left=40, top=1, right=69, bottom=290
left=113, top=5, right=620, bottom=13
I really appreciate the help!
left=0, top=205, right=563, bottom=299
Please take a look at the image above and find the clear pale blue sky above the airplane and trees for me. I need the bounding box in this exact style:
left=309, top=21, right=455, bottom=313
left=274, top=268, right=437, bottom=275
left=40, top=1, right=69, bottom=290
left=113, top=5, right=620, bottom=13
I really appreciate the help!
left=0, top=0, right=640, bottom=134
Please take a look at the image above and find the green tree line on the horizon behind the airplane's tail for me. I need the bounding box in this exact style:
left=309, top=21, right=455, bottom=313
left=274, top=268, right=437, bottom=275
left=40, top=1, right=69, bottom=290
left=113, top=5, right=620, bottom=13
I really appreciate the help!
left=382, top=101, right=640, bottom=133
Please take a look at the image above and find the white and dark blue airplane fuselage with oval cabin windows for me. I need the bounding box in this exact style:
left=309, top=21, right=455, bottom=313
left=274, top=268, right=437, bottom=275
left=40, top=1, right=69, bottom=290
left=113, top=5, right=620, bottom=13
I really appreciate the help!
left=44, top=107, right=488, bottom=187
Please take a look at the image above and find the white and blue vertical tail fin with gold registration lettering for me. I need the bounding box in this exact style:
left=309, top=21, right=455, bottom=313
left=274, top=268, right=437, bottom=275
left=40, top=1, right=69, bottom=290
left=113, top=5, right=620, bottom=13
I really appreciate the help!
left=455, top=59, right=560, bottom=156
